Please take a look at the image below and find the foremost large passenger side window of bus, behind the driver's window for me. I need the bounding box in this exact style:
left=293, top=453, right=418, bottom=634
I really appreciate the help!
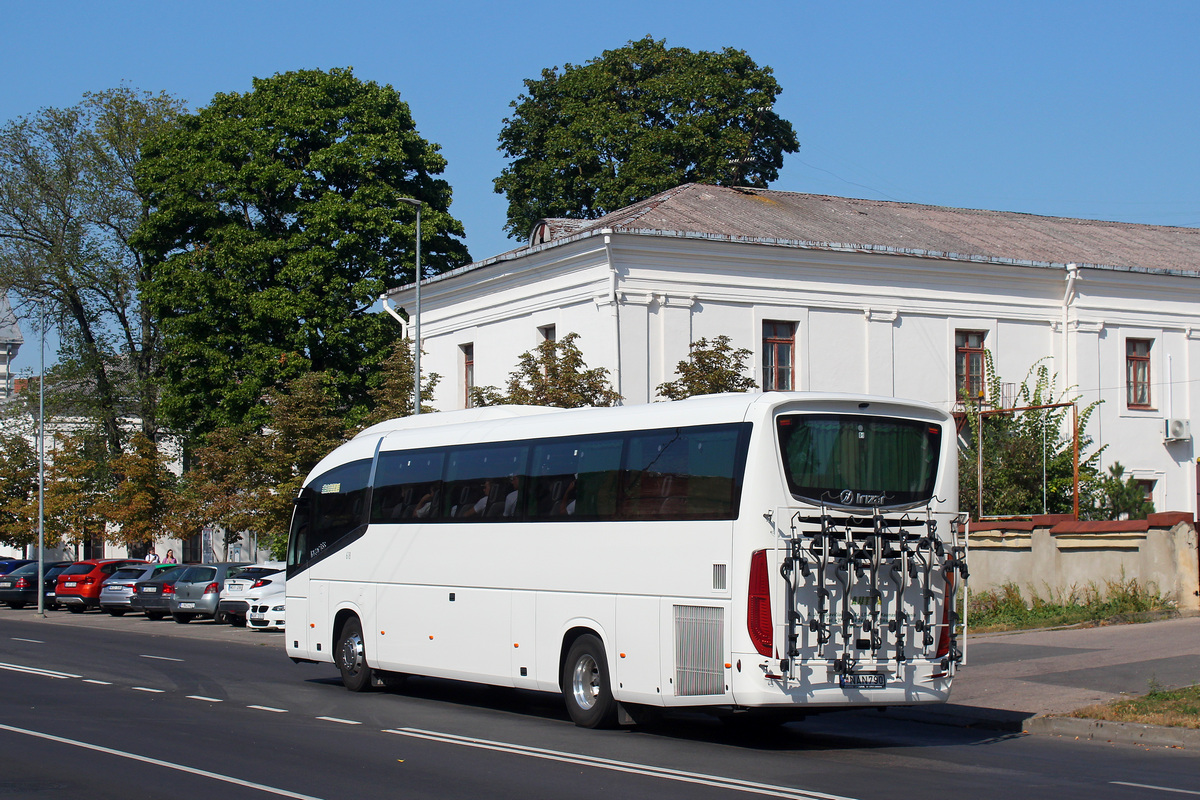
left=371, top=450, right=445, bottom=523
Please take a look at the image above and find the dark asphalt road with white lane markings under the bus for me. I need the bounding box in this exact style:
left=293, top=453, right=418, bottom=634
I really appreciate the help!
left=0, top=609, right=1200, bottom=800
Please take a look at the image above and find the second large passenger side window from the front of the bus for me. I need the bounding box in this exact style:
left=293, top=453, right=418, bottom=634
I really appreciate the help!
left=442, top=444, right=529, bottom=522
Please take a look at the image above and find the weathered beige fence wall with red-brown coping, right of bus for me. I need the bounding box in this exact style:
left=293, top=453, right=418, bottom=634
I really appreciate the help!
left=967, top=512, right=1200, bottom=612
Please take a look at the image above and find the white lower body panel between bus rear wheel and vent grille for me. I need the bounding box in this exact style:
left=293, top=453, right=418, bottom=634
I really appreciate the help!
left=608, top=595, right=670, bottom=705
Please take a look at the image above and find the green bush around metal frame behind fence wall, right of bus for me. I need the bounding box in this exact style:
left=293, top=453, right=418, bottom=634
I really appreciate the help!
left=959, top=350, right=1104, bottom=518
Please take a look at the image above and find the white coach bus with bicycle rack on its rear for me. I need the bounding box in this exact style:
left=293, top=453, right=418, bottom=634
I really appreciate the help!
left=287, top=392, right=966, bottom=727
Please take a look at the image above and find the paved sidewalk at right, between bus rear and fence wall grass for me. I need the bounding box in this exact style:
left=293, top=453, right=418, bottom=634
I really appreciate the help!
left=888, top=616, right=1200, bottom=750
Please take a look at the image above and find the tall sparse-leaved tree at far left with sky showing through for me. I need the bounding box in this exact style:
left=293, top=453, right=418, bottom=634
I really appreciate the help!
left=0, top=88, right=182, bottom=456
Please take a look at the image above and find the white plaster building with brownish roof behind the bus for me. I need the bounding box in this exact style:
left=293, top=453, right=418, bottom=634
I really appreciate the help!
left=381, top=185, right=1200, bottom=513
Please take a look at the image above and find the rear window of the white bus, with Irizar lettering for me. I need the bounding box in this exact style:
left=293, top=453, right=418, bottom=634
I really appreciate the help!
left=776, top=414, right=942, bottom=509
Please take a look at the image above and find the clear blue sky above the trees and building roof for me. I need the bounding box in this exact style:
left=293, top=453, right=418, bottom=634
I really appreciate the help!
left=0, top=0, right=1200, bottom=371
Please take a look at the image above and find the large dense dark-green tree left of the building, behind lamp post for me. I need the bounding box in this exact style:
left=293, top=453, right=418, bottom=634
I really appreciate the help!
left=136, top=70, right=469, bottom=434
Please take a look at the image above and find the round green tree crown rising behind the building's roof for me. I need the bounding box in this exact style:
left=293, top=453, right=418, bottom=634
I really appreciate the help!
left=494, top=36, right=799, bottom=237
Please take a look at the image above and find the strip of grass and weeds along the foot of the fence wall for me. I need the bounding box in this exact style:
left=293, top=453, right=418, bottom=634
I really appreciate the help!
left=967, top=578, right=1172, bottom=632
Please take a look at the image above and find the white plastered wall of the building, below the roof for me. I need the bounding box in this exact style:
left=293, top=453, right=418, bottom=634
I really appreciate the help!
left=395, top=235, right=1200, bottom=520
